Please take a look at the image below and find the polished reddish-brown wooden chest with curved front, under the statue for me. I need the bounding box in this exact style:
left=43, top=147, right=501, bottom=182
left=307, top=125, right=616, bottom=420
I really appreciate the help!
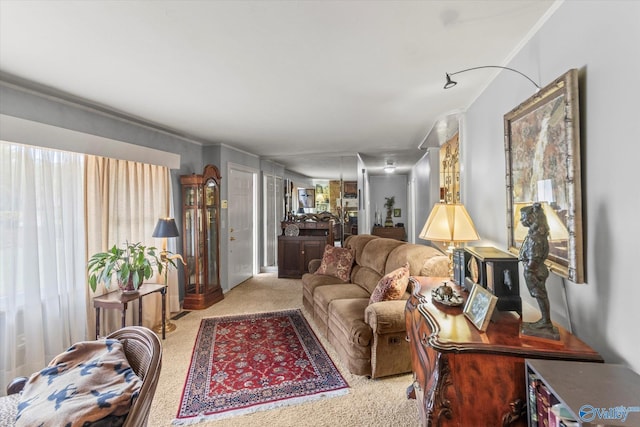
left=405, top=277, right=603, bottom=426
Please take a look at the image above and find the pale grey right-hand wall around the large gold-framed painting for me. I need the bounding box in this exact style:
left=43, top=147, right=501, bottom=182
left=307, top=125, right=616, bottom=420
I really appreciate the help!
left=458, top=1, right=640, bottom=372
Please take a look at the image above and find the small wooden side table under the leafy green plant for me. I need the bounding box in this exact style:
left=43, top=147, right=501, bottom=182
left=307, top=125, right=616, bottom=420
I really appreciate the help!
left=93, top=283, right=167, bottom=339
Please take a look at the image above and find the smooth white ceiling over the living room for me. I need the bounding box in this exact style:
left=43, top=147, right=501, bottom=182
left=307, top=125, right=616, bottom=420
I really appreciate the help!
left=0, top=0, right=555, bottom=179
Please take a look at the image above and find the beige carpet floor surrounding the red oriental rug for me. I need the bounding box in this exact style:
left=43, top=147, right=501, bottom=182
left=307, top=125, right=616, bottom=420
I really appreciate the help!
left=149, top=273, right=419, bottom=427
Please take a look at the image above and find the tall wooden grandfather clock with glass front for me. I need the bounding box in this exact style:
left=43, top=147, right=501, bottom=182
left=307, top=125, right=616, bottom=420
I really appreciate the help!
left=180, top=165, right=224, bottom=310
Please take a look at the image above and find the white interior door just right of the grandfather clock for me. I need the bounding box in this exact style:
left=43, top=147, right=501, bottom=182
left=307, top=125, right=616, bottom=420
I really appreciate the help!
left=227, top=164, right=258, bottom=289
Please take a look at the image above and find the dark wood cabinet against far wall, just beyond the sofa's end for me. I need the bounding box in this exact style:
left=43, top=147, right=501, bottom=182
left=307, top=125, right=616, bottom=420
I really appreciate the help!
left=278, top=235, right=327, bottom=279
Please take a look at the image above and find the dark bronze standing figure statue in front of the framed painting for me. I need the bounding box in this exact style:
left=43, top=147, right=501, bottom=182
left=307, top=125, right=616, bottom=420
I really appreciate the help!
left=518, top=203, right=560, bottom=340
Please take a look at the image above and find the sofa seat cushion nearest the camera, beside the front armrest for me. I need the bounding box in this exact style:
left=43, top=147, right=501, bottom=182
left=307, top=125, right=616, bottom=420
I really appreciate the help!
left=329, top=298, right=373, bottom=350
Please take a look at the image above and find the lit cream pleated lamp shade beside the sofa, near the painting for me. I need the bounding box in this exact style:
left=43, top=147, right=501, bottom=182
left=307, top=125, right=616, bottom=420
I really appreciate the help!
left=419, top=203, right=480, bottom=242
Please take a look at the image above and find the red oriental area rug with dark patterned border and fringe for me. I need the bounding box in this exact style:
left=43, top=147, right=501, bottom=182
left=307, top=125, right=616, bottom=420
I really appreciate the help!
left=173, top=310, right=349, bottom=425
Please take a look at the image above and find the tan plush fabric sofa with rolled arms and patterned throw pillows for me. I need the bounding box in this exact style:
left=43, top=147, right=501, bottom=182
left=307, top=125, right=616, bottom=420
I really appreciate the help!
left=302, top=234, right=448, bottom=378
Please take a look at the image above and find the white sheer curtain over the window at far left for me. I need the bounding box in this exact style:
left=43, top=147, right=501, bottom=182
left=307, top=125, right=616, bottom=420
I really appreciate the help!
left=0, top=141, right=87, bottom=395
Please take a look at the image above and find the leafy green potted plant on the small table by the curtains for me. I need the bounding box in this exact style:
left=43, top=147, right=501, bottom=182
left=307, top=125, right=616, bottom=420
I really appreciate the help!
left=87, top=242, right=175, bottom=292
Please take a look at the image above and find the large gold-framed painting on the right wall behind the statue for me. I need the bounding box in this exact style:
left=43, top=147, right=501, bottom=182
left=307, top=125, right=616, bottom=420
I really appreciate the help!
left=504, top=69, right=584, bottom=283
